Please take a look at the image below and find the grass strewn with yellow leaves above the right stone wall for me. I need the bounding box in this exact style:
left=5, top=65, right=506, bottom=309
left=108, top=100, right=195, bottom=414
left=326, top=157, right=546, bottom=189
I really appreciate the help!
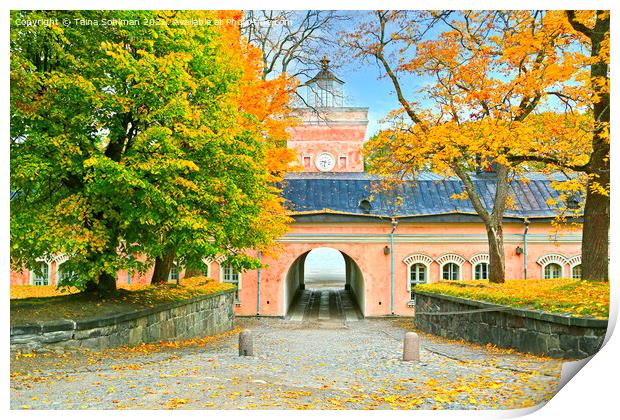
left=416, top=279, right=609, bottom=319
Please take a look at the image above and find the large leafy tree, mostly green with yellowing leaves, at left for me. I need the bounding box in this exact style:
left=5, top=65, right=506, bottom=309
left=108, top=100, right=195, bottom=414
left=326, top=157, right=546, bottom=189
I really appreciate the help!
left=11, top=11, right=294, bottom=291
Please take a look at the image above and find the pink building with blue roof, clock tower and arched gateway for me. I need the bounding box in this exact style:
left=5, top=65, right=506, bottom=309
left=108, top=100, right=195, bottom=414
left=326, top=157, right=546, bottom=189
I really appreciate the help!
left=11, top=59, right=581, bottom=316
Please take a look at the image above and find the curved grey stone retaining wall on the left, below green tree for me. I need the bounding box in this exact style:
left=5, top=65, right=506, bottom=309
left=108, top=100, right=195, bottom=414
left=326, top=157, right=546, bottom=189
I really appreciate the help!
left=11, top=290, right=234, bottom=350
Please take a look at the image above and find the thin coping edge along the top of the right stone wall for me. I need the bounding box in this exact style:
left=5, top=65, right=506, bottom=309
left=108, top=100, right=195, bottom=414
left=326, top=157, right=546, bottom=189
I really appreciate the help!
left=415, top=291, right=608, bottom=328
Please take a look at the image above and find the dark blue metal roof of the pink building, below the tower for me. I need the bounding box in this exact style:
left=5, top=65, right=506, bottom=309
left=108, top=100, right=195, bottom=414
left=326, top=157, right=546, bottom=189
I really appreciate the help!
left=283, top=172, right=576, bottom=218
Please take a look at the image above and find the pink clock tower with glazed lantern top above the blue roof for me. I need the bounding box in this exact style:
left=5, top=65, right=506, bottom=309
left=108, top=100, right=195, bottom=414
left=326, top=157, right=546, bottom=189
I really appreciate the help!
left=288, top=57, right=368, bottom=173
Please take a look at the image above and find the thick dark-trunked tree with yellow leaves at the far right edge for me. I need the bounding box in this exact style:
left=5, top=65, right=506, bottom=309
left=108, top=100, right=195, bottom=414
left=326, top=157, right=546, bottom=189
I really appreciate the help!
left=502, top=10, right=610, bottom=281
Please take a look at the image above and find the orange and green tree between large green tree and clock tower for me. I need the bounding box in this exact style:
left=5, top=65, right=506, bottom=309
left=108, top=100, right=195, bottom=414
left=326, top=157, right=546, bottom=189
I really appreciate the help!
left=152, top=11, right=296, bottom=283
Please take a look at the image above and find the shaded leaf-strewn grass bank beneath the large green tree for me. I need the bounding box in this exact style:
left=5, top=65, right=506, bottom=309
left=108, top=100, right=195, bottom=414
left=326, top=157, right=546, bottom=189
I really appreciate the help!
left=11, top=277, right=234, bottom=325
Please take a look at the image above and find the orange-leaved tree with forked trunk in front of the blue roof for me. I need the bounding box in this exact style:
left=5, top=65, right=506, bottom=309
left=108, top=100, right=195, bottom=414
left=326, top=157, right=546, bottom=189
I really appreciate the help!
left=344, top=11, right=587, bottom=282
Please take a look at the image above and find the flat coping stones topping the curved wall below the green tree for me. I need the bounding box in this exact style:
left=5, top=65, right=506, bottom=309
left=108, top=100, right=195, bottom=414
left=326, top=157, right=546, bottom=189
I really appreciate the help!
left=11, top=289, right=234, bottom=336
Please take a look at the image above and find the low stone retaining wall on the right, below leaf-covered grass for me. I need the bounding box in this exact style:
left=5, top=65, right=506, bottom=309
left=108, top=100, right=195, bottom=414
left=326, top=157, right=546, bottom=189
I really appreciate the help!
left=415, top=292, right=607, bottom=359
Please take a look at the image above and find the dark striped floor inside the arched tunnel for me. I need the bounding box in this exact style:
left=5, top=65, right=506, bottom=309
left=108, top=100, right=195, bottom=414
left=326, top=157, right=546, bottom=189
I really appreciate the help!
left=287, top=288, right=363, bottom=323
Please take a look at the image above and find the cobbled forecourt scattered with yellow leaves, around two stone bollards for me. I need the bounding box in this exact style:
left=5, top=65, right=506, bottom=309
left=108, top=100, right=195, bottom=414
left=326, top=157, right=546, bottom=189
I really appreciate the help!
left=11, top=319, right=561, bottom=409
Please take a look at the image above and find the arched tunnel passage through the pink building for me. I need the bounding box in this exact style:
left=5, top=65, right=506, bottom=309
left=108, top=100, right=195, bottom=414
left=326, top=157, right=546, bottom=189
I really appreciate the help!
left=284, top=247, right=365, bottom=321
